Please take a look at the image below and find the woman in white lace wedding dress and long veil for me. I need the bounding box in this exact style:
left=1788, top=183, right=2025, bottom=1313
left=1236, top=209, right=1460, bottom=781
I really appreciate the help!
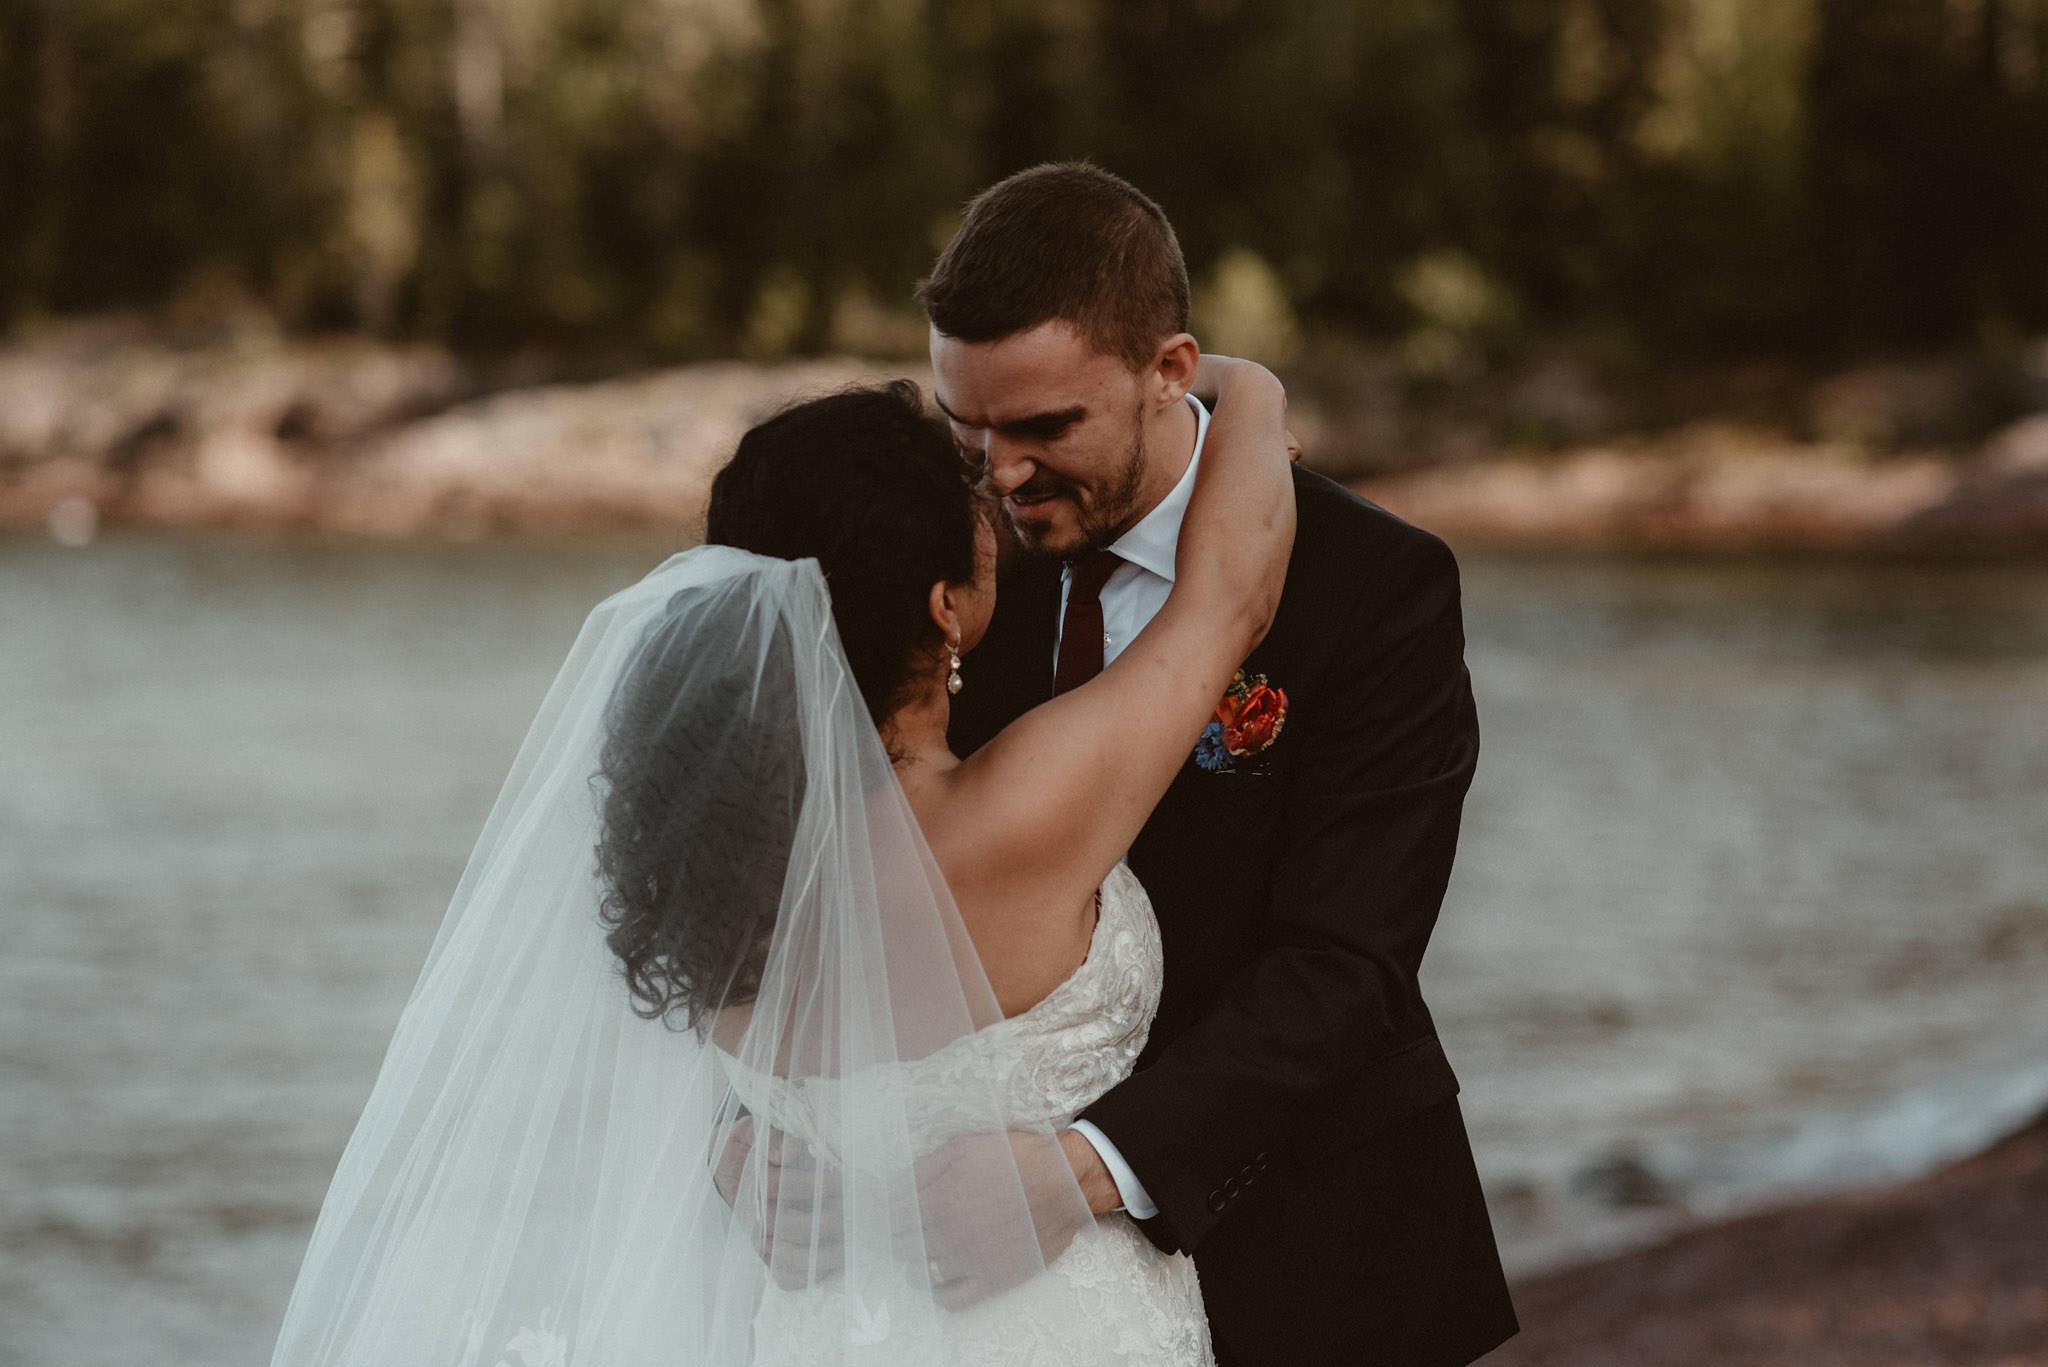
left=272, top=359, right=1294, bottom=1367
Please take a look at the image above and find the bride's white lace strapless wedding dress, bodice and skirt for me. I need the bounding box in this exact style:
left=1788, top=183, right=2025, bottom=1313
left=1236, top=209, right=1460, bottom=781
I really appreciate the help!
left=733, top=865, right=1214, bottom=1367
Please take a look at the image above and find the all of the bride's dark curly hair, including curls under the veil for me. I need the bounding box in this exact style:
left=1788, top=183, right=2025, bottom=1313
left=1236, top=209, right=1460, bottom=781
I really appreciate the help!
left=596, top=381, right=985, bottom=1027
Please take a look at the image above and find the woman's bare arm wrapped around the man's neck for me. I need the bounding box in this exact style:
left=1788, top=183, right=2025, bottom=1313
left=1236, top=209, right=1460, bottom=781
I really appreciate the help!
left=954, top=361, right=1294, bottom=902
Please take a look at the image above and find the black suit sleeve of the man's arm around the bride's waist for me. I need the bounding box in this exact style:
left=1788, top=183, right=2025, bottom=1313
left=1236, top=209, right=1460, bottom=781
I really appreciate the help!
left=1085, top=527, right=1479, bottom=1250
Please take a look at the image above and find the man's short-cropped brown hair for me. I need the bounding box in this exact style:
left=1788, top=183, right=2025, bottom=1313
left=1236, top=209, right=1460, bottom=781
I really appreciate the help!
left=918, top=162, right=1188, bottom=371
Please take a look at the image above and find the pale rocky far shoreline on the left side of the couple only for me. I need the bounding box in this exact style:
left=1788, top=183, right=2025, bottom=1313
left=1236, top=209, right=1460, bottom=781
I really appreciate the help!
left=0, top=327, right=893, bottom=539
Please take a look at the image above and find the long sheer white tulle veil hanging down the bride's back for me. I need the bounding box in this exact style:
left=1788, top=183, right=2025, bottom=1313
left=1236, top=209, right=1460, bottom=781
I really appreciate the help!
left=272, top=547, right=1081, bottom=1367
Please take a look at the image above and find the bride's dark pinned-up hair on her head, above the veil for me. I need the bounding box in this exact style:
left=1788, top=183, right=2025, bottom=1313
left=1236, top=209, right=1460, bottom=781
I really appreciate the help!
left=705, top=379, right=983, bottom=723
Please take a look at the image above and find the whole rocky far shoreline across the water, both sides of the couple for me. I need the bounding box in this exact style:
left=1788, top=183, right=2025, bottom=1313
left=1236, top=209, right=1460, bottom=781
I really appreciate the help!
left=0, top=322, right=2048, bottom=553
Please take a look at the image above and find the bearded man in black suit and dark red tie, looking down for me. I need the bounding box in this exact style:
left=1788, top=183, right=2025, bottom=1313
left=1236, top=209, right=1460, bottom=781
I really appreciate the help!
left=937, top=164, right=1516, bottom=1367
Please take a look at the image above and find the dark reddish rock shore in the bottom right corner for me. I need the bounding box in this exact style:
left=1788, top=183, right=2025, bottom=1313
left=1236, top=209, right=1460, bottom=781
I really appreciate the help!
left=1485, top=1115, right=2048, bottom=1367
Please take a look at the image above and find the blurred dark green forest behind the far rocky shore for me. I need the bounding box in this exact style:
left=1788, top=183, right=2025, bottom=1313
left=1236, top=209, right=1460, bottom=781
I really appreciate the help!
left=0, top=0, right=2048, bottom=371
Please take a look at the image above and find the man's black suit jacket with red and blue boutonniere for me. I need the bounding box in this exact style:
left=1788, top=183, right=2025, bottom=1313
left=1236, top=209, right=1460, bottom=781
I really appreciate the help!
left=952, top=469, right=1516, bottom=1367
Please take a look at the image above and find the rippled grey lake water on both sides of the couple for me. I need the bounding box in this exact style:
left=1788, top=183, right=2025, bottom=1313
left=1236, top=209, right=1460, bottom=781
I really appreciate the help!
left=0, top=537, right=2048, bottom=1367
